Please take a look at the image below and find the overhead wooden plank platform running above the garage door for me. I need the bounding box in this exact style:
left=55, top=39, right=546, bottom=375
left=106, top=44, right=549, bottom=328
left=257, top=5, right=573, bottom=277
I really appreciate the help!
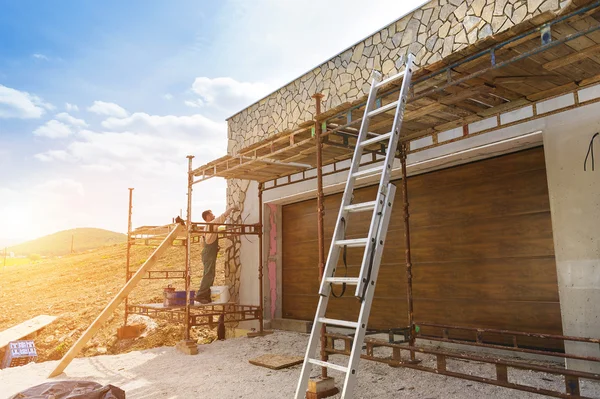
left=192, top=1, right=600, bottom=182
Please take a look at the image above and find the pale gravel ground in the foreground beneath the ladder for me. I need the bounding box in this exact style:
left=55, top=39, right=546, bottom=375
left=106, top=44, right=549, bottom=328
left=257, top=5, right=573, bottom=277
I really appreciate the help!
left=0, top=332, right=600, bottom=399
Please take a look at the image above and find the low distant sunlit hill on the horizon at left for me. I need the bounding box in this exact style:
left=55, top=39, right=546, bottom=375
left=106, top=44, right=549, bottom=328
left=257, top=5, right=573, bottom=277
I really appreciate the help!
left=8, top=228, right=127, bottom=256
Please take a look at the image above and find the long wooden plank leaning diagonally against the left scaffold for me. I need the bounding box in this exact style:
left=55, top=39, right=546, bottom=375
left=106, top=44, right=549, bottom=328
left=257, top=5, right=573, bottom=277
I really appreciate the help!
left=48, top=224, right=185, bottom=378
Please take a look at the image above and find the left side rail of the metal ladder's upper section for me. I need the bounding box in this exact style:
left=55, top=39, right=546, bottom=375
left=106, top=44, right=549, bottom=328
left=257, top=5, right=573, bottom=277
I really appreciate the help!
left=319, top=72, right=381, bottom=296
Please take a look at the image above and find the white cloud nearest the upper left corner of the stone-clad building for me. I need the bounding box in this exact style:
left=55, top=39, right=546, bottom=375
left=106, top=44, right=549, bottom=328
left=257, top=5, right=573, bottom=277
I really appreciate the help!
left=190, top=76, right=272, bottom=113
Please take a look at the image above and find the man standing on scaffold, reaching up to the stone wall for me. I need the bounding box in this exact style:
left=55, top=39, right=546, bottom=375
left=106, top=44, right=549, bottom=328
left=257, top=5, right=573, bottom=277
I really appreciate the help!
left=195, top=206, right=237, bottom=303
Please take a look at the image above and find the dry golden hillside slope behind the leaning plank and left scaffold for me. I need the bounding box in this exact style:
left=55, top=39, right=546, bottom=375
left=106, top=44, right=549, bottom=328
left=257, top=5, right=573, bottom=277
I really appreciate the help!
left=0, top=244, right=225, bottom=361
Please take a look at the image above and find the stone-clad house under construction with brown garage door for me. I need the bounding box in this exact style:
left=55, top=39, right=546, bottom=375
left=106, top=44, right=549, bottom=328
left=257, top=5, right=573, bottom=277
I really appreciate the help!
left=190, top=0, right=600, bottom=397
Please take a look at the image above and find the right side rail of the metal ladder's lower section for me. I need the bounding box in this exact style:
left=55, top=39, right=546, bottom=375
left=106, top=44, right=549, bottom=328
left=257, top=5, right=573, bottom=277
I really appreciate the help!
left=341, top=183, right=396, bottom=399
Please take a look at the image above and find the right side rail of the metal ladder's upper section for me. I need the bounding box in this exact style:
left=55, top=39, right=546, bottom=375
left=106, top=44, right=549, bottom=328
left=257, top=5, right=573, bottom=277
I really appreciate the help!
left=354, top=54, right=414, bottom=299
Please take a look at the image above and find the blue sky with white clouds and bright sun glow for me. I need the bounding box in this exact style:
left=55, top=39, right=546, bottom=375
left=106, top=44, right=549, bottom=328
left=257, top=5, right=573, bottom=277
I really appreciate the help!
left=0, top=0, right=424, bottom=246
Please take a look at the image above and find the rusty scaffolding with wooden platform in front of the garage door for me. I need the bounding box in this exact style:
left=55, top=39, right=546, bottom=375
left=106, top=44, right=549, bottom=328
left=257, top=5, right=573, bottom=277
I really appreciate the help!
left=190, top=1, right=600, bottom=398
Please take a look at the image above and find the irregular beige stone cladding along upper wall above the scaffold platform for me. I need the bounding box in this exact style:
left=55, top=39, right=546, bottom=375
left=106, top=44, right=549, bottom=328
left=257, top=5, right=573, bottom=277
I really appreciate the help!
left=228, top=0, right=569, bottom=155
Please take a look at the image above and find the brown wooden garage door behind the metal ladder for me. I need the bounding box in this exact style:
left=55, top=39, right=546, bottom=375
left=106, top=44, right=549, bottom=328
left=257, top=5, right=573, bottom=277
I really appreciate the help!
left=283, top=147, right=562, bottom=342
